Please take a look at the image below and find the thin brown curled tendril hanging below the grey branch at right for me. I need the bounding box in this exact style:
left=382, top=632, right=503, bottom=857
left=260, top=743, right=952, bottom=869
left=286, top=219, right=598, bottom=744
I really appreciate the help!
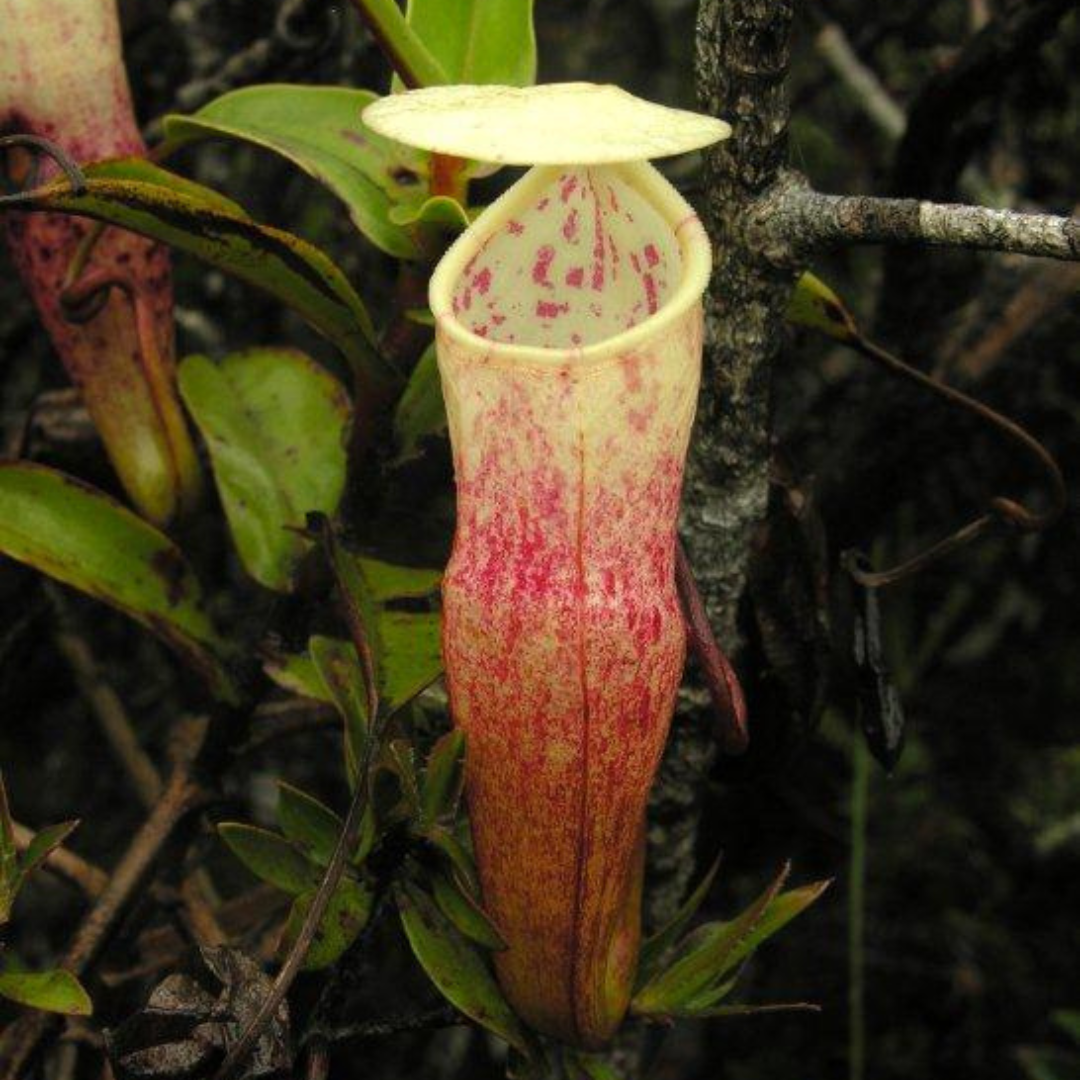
left=841, top=332, right=1068, bottom=589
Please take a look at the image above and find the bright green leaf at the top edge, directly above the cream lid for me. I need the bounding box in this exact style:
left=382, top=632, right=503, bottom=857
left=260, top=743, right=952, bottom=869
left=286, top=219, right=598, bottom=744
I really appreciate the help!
left=397, top=0, right=537, bottom=86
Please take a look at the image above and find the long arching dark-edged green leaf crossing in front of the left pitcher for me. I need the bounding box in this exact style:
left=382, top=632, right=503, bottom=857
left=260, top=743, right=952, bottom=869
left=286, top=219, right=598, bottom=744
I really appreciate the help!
left=18, top=162, right=399, bottom=404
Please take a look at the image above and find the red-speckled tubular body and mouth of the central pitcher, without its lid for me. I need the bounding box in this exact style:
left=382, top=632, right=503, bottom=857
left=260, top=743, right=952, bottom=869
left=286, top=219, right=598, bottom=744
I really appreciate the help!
left=431, top=162, right=710, bottom=1045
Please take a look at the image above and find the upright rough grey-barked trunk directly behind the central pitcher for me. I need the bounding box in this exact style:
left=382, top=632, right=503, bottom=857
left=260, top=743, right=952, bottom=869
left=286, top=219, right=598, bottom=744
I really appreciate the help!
left=649, top=0, right=794, bottom=920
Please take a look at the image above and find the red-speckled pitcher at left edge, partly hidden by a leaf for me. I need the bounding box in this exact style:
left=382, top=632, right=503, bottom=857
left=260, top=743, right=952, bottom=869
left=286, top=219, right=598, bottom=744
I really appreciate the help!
left=0, top=0, right=200, bottom=523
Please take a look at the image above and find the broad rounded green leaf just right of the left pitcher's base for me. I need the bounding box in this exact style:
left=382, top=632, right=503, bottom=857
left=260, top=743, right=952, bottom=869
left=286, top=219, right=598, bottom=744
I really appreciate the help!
left=179, top=349, right=351, bottom=592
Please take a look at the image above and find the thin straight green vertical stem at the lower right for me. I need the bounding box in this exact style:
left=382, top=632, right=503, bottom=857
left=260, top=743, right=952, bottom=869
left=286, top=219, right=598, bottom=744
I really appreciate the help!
left=848, top=731, right=870, bottom=1080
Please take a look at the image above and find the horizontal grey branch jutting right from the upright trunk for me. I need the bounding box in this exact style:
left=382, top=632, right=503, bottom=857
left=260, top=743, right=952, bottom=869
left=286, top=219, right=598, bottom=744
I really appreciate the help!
left=756, top=174, right=1080, bottom=262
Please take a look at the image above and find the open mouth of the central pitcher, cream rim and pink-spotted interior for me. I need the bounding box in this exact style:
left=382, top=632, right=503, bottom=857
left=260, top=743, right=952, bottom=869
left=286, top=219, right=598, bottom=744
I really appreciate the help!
left=430, top=161, right=712, bottom=369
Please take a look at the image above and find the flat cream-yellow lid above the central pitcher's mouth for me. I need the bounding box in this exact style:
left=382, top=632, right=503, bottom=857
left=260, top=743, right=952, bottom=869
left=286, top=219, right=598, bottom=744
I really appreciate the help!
left=363, top=82, right=731, bottom=165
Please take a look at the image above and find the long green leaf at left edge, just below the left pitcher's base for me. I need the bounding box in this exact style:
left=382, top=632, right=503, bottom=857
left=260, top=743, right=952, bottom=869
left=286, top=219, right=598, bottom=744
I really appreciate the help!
left=0, top=462, right=237, bottom=700
